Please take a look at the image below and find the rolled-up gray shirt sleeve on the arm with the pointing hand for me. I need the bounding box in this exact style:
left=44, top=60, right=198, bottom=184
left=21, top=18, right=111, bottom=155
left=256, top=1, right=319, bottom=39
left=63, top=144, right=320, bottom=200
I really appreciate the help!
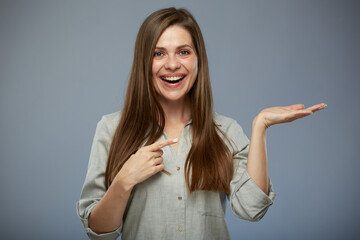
left=76, top=117, right=122, bottom=240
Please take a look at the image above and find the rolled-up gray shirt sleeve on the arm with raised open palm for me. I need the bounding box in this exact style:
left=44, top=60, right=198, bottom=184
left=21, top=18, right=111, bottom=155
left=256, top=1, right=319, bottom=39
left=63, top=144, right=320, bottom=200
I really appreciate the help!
left=228, top=121, right=276, bottom=221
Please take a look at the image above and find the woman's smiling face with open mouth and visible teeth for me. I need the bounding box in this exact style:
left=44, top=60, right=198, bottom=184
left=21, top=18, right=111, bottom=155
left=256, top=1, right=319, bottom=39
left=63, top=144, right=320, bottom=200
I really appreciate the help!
left=152, top=25, right=198, bottom=105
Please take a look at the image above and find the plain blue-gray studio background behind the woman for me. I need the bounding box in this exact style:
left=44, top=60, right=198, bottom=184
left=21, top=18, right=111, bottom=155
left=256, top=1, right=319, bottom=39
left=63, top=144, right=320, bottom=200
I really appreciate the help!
left=0, top=0, right=360, bottom=239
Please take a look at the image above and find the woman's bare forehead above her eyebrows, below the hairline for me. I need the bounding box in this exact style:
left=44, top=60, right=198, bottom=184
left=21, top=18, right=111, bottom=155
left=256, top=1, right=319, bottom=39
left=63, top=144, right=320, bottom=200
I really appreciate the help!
left=156, top=25, right=193, bottom=48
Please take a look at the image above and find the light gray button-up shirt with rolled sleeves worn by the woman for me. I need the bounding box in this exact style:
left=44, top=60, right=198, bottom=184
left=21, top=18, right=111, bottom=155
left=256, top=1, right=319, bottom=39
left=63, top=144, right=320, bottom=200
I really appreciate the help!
left=77, top=112, right=275, bottom=240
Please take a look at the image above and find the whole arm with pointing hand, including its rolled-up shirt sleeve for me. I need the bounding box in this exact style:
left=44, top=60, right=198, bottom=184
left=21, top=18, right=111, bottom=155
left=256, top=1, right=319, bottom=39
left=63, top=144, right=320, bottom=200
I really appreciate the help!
left=77, top=116, right=178, bottom=239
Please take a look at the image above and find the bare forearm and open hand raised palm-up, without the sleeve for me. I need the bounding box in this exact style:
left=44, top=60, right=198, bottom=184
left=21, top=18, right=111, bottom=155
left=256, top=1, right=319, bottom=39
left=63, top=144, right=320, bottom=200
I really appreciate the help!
left=247, top=103, right=327, bottom=194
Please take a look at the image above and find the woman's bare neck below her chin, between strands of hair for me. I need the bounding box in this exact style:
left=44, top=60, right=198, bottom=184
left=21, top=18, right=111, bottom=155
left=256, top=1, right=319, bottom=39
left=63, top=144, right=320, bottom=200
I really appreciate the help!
left=160, top=98, right=191, bottom=124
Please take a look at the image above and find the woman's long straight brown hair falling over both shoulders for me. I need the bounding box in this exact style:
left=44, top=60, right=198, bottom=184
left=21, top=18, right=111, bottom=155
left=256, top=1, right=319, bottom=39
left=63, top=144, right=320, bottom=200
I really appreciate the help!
left=105, top=8, right=233, bottom=193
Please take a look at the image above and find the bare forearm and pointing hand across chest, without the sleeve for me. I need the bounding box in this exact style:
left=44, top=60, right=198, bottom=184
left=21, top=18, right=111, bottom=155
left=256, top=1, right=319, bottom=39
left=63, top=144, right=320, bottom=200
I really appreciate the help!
left=89, top=139, right=177, bottom=233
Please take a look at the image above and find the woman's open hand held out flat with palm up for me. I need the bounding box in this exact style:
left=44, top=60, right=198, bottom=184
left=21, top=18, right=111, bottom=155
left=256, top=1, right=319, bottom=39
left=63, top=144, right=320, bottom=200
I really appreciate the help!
left=256, top=103, right=327, bottom=128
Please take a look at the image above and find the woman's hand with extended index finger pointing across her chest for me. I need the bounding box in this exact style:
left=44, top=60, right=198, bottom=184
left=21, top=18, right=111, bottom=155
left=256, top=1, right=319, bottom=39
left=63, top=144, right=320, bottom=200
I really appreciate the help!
left=114, top=138, right=178, bottom=189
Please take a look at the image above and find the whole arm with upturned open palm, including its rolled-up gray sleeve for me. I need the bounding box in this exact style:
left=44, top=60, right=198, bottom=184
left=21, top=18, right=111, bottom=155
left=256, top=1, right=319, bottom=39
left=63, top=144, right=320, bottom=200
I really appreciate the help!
left=231, top=104, right=326, bottom=221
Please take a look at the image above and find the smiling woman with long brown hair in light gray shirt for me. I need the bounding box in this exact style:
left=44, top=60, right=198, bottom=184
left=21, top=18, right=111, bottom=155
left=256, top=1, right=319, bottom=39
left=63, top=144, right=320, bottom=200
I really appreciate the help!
left=77, top=8, right=326, bottom=239
